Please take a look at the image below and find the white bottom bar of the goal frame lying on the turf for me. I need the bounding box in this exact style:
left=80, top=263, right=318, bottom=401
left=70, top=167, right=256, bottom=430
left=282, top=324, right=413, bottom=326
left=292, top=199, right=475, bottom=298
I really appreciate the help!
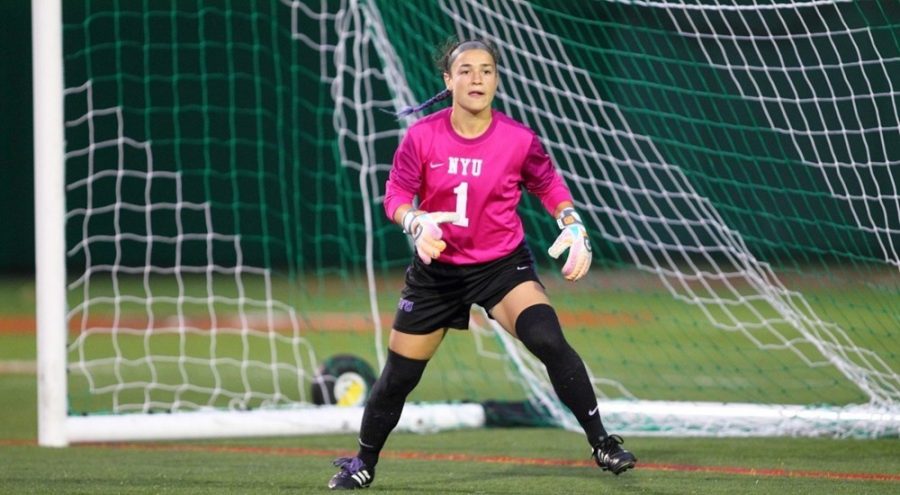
left=44, top=400, right=900, bottom=444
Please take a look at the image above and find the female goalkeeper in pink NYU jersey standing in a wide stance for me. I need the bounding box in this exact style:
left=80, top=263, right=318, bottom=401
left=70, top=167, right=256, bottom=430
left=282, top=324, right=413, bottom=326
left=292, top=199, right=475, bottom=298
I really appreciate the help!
left=328, top=40, right=636, bottom=489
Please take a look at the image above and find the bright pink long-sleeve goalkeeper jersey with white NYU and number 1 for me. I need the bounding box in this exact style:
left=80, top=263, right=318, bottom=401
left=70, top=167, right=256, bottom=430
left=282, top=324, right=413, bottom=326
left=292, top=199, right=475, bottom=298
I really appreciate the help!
left=384, top=108, right=572, bottom=265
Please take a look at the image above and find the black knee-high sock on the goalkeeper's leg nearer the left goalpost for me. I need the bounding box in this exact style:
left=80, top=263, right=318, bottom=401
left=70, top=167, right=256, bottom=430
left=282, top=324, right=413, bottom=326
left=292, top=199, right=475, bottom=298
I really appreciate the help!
left=357, top=350, right=428, bottom=468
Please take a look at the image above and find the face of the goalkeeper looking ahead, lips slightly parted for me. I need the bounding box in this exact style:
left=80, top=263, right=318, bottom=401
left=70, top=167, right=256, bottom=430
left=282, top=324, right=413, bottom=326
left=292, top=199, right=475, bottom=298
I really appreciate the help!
left=444, top=49, right=499, bottom=115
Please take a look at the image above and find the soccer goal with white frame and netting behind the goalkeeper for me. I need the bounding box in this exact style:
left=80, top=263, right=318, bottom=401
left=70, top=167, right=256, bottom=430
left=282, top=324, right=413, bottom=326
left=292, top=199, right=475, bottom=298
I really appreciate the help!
left=33, top=0, right=900, bottom=445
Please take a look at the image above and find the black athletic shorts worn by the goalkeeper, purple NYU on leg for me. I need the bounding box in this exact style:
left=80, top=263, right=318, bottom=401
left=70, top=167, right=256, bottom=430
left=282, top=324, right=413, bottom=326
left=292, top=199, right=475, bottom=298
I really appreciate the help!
left=394, top=242, right=543, bottom=334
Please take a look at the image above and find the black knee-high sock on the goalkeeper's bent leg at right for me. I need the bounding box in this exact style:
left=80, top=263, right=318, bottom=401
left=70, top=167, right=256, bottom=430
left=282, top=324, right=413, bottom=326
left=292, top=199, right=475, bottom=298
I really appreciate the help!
left=516, top=304, right=606, bottom=446
